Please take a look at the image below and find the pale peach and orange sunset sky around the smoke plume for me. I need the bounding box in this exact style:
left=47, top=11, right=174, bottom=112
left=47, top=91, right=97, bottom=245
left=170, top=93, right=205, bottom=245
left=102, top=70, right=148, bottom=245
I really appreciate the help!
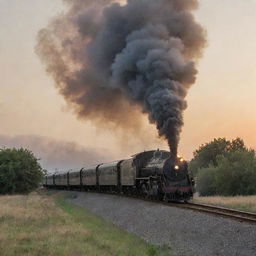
left=0, top=0, right=256, bottom=168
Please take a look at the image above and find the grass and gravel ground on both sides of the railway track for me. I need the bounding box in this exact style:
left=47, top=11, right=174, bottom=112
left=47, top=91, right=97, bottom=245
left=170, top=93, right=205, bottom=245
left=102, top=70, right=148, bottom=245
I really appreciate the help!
left=0, top=191, right=256, bottom=256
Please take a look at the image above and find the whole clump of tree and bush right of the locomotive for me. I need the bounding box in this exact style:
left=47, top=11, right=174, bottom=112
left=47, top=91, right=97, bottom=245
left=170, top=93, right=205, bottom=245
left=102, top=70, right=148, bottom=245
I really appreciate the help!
left=189, top=138, right=256, bottom=196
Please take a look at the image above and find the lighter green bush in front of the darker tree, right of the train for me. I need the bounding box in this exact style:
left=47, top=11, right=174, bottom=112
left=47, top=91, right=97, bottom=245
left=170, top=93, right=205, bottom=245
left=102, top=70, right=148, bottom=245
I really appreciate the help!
left=197, top=150, right=256, bottom=196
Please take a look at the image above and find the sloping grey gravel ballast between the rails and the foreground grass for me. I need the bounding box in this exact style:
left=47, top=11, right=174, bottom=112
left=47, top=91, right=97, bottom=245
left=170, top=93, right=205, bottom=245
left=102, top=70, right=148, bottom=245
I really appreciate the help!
left=67, top=192, right=256, bottom=256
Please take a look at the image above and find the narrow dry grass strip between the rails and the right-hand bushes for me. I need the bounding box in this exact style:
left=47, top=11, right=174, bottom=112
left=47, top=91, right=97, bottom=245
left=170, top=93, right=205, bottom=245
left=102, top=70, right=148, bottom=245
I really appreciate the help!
left=193, top=196, right=256, bottom=213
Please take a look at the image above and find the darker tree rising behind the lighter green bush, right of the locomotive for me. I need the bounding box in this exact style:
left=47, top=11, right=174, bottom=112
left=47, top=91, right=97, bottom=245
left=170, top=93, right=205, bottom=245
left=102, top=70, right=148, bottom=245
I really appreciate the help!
left=189, top=138, right=247, bottom=175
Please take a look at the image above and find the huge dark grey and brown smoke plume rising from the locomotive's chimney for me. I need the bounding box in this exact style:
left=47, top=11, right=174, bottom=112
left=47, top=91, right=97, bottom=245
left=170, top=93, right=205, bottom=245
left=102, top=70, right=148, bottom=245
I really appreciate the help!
left=36, top=0, right=205, bottom=154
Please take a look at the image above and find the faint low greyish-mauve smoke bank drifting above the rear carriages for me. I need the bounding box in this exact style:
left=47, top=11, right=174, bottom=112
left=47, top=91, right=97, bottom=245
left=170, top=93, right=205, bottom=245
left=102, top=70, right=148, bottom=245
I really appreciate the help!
left=0, top=135, right=109, bottom=172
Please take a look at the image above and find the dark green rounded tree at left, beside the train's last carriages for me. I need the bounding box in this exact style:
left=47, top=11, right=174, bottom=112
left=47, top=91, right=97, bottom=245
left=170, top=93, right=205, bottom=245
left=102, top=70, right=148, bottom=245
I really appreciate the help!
left=0, top=148, right=44, bottom=194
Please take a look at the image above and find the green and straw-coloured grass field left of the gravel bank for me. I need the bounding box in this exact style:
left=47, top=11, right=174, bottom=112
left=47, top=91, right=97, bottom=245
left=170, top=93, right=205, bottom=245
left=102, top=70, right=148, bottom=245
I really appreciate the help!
left=0, top=193, right=172, bottom=256
